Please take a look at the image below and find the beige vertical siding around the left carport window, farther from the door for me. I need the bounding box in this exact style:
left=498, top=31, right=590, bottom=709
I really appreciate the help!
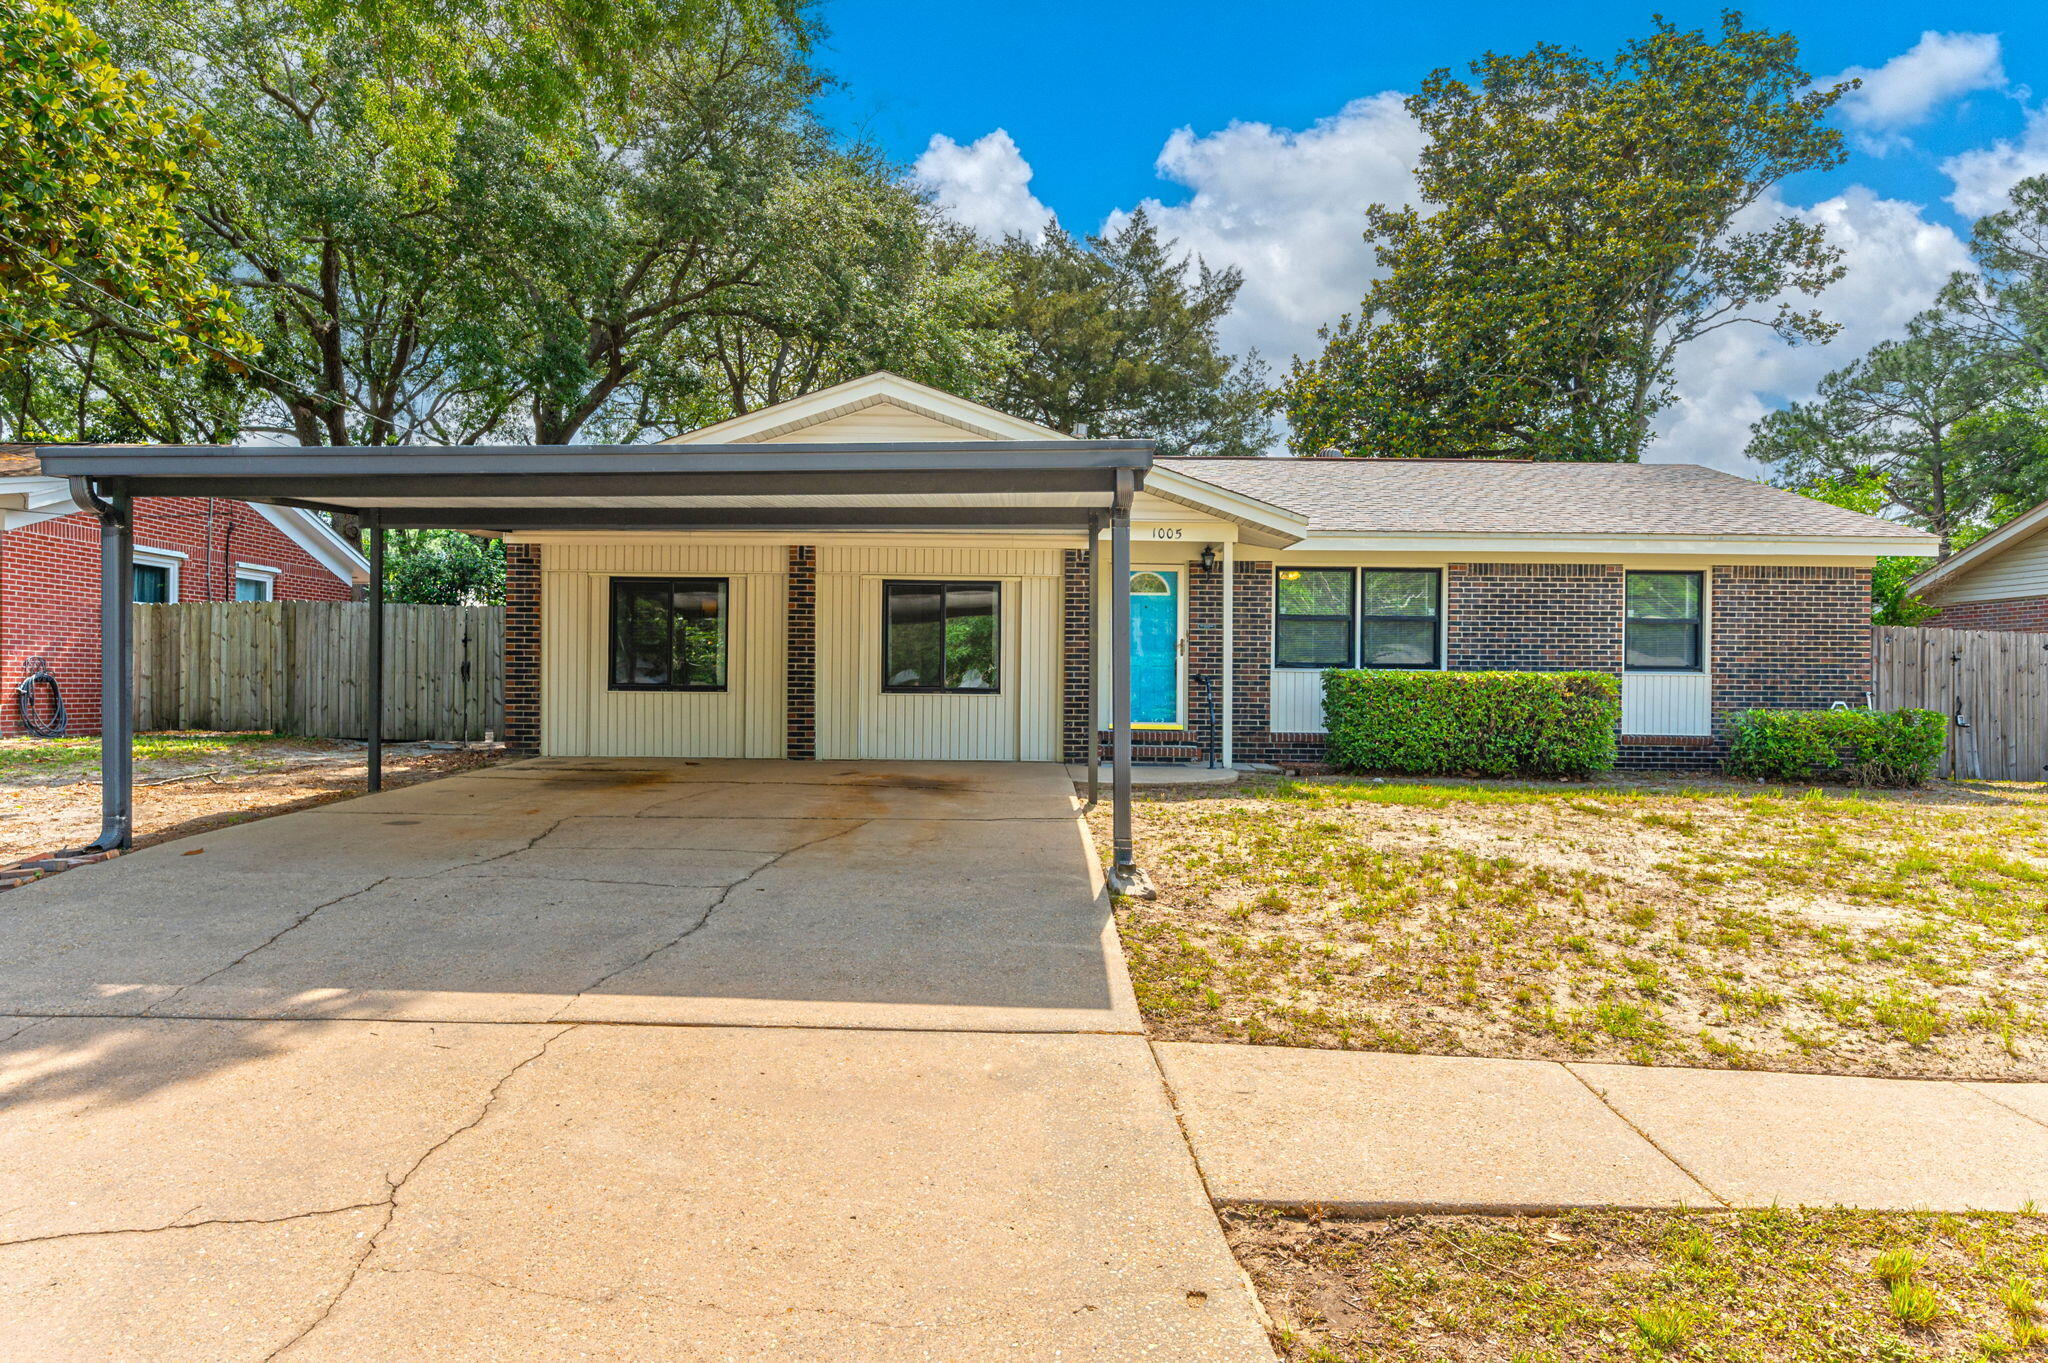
left=541, top=540, right=786, bottom=757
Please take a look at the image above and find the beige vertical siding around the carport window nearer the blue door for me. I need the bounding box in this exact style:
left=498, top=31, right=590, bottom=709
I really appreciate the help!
left=817, top=544, right=1061, bottom=761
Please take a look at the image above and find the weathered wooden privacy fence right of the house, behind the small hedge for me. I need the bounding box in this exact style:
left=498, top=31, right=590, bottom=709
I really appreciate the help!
left=1872, top=626, right=2048, bottom=782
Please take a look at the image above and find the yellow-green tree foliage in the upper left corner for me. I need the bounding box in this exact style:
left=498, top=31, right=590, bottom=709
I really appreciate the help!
left=0, top=0, right=254, bottom=436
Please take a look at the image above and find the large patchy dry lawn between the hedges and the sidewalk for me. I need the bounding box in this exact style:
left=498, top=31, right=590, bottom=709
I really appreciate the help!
left=1118, top=780, right=2048, bottom=1079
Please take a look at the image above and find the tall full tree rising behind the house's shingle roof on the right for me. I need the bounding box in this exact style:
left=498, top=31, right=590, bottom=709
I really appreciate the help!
left=1282, top=12, right=1847, bottom=460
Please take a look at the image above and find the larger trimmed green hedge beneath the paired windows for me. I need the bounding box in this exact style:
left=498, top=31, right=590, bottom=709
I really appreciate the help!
left=1323, top=671, right=1622, bottom=778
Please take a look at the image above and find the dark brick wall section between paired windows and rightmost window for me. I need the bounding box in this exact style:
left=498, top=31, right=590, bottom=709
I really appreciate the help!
left=1444, top=563, right=1622, bottom=673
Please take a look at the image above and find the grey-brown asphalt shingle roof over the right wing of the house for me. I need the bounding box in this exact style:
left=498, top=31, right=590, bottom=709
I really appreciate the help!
left=1159, top=458, right=1921, bottom=538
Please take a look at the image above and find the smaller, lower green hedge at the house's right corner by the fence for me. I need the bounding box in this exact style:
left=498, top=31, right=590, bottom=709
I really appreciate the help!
left=1729, top=710, right=1948, bottom=786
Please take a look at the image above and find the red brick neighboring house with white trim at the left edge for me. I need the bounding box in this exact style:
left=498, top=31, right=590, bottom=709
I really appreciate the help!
left=0, top=446, right=369, bottom=737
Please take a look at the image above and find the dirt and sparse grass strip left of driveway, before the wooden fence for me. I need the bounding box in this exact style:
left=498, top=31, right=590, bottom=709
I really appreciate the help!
left=0, top=733, right=494, bottom=866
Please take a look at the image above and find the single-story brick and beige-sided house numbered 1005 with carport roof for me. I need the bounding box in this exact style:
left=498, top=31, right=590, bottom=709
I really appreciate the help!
left=45, top=375, right=1931, bottom=875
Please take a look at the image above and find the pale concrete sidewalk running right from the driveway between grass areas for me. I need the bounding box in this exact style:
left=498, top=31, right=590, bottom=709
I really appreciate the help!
left=1155, top=1044, right=2048, bottom=1214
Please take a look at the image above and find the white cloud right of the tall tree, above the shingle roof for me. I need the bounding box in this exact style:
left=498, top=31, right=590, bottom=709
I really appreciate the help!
left=1647, top=186, right=1970, bottom=475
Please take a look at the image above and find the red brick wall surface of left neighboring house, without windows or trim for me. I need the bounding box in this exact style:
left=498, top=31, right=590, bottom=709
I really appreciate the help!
left=0, top=497, right=354, bottom=737
